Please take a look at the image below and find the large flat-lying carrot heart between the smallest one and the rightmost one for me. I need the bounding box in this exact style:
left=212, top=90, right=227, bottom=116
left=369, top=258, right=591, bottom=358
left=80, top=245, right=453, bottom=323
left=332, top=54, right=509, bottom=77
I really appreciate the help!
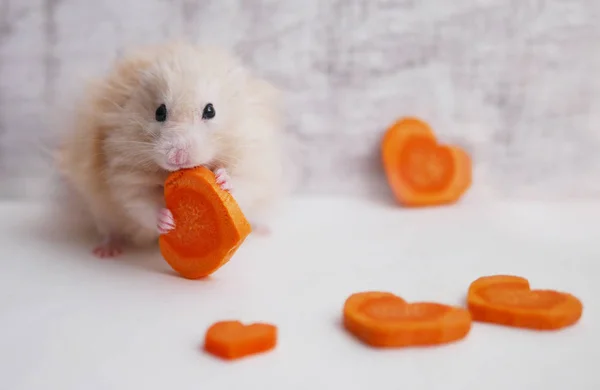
left=343, top=291, right=471, bottom=347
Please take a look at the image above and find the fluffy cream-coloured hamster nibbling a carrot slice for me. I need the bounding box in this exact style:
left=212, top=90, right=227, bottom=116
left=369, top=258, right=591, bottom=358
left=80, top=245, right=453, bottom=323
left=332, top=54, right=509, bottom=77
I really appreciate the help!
left=57, top=42, right=283, bottom=257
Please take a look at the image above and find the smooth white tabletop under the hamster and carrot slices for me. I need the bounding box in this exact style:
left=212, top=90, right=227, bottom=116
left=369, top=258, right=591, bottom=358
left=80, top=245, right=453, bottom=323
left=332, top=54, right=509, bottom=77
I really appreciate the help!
left=0, top=198, right=600, bottom=390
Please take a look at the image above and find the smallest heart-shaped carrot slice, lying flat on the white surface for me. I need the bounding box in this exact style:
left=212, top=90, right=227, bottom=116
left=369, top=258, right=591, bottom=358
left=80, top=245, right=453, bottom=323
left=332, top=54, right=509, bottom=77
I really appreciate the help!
left=204, top=321, right=277, bottom=360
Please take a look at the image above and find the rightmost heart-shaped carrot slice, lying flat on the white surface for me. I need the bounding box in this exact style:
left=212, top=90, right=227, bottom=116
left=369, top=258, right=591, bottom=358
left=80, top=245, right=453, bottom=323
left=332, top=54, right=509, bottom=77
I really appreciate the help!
left=467, top=275, right=583, bottom=330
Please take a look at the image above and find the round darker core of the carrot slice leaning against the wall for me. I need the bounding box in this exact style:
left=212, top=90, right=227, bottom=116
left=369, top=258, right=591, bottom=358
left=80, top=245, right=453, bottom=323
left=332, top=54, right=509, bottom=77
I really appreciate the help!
left=399, top=136, right=454, bottom=193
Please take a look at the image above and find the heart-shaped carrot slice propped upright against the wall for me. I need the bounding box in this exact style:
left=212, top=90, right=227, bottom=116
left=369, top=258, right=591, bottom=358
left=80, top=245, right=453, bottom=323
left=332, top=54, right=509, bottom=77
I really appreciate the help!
left=381, top=118, right=472, bottom=207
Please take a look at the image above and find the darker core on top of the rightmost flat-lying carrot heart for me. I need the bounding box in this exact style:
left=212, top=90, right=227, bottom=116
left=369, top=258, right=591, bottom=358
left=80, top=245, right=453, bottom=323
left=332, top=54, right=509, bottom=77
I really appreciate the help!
left=478, top=287, right=565, bottom=309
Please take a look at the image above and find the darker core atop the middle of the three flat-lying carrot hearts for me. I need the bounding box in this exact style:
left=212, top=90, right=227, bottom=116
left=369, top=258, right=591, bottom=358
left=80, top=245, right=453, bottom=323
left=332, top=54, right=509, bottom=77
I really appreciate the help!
left=360, top=297, right=447, bottom=322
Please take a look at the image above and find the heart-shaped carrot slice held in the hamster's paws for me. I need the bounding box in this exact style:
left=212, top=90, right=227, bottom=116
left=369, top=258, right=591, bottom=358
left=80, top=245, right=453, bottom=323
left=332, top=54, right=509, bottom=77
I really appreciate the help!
left=159, top=167, right=252, bottom=279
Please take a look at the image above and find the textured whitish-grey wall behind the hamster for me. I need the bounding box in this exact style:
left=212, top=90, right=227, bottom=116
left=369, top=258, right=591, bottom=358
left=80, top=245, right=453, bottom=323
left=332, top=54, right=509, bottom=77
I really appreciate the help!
left=0, top=0, right=600, bottom=198
